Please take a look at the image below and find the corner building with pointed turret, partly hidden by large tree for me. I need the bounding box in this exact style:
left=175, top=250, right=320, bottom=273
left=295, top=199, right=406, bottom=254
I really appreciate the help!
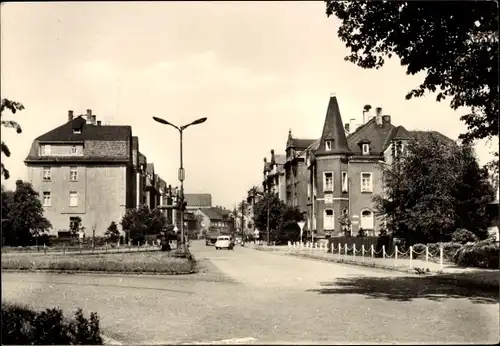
left=302, top=96, right=454, bottom=238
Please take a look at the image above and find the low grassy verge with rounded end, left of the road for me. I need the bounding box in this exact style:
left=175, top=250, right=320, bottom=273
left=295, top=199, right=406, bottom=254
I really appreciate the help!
left=2, top=252, right=196, bottom=275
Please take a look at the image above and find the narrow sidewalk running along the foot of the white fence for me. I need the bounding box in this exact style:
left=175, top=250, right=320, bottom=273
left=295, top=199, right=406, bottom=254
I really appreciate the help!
left=245, top=244, right=500, bottom=290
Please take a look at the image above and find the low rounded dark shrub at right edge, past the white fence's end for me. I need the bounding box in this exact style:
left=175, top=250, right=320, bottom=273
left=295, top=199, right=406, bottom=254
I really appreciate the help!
left=453, top=240, right=500, bottom=269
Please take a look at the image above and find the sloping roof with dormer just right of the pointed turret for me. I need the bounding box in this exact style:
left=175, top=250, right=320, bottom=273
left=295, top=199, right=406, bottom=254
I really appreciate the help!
left=347, top=118, right=394, bottom=155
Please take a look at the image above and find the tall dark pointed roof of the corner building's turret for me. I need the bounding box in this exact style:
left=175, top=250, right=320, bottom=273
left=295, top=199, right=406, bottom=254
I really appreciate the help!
left=315, top=96, right=350, bottom=155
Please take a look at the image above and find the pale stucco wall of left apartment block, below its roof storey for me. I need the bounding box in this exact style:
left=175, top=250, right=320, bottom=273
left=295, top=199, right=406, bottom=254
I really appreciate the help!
left=28, top=165, right=127, bottom=236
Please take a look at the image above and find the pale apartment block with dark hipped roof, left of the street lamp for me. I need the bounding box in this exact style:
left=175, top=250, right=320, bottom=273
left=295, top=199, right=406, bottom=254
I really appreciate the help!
left=24, top=109, right=168, bottom=236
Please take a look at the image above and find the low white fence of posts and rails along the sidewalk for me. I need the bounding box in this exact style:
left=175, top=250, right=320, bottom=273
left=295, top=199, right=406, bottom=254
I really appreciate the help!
left=286, top=242, right=444, bottom=270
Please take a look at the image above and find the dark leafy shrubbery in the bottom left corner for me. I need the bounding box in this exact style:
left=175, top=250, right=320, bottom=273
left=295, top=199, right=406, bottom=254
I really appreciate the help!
left=2, top=302, right=103, bottom=345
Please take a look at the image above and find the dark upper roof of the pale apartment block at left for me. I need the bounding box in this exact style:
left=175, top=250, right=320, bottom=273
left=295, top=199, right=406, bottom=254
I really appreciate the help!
left=36, top=116, right=132, bottom=142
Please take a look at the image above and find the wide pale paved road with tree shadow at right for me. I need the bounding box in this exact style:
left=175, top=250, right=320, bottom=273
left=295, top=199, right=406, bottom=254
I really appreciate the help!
left=2, top=242, right=499, bottom=344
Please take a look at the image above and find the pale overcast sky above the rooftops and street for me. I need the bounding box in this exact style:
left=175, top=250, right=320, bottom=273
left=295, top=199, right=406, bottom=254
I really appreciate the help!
left=1, top=1, right=493, bottom=207
